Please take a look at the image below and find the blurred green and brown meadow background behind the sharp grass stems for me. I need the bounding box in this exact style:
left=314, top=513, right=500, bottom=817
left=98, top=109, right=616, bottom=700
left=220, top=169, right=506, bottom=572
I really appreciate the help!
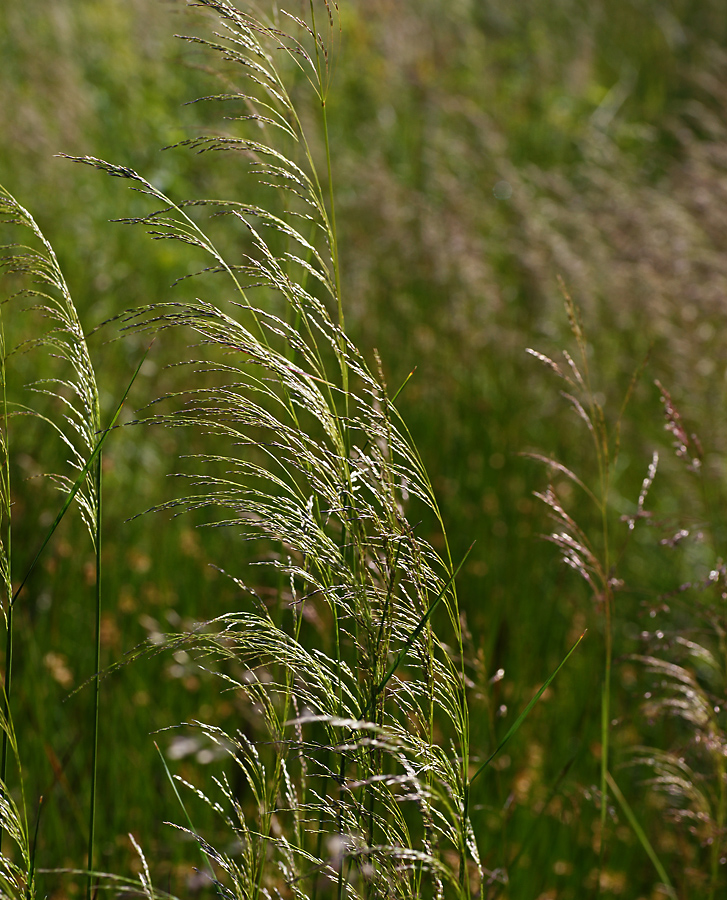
left=0, top=0, right=727, bottom=900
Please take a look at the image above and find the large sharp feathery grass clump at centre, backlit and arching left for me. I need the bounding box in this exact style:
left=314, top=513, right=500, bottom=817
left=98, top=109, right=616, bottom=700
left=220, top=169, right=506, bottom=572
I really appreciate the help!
left=71, top=0, right=482, bottom=898
